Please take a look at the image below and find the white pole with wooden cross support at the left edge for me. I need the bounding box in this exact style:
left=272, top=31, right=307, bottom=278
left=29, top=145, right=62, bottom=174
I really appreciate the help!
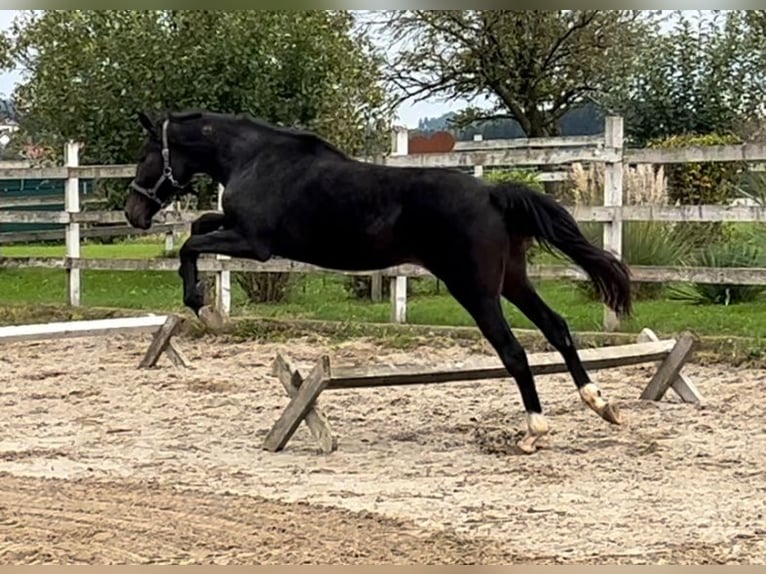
left=0, top=315, right=189, bottom=369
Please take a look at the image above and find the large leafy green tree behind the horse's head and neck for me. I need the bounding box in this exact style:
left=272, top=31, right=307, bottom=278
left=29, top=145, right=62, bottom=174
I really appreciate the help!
left=0, top=10, right=388, bottom=178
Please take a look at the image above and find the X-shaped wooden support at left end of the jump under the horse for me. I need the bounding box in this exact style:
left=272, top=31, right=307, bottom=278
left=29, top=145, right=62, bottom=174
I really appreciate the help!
left=263, top=355, right=338, bottom=454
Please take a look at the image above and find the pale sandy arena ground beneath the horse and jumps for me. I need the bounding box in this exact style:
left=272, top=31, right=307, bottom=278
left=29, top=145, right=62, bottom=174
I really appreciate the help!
left=0, top=335, right=766, bottom=564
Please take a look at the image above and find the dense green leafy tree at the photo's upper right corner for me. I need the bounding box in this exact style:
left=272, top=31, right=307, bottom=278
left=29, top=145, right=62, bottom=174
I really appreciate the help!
left=604, top=10, right=766, bottom=145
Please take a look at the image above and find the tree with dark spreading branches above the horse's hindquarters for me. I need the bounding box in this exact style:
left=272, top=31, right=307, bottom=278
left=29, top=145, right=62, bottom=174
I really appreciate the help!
left=386, top=10, right=656, bottom=137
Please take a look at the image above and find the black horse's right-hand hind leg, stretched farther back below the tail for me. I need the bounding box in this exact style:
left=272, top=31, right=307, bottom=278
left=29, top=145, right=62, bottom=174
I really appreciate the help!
left=503, top=267, right=620, bottom=424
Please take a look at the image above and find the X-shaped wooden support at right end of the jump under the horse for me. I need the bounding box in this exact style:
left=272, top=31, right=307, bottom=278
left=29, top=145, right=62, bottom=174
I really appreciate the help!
left=638, top=329, right=702, bottom=403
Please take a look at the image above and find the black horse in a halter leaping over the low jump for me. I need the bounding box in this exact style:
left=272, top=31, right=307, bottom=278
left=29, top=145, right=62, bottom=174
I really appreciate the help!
left=125, top=111, right=631, bottom=452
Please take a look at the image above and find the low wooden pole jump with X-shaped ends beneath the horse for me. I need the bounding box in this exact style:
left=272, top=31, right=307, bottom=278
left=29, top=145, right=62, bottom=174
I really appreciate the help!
left=263, top=329, right=702, bottom=453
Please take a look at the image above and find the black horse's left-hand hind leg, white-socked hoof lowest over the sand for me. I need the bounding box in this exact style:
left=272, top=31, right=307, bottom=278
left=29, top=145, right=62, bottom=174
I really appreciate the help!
left=444, top=280, right=548, bottom=453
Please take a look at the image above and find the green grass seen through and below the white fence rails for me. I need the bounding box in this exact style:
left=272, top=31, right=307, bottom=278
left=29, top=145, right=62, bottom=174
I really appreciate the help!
left=0, top=236, right=766, bottom=338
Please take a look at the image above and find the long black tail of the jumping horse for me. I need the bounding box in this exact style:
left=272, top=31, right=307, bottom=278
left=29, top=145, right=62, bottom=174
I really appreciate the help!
left=490, top=183, right=631, bottom=316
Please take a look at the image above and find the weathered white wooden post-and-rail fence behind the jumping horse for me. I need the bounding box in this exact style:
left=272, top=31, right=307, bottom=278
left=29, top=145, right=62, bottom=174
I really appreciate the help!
left=0, top=117, right=766, bottom=329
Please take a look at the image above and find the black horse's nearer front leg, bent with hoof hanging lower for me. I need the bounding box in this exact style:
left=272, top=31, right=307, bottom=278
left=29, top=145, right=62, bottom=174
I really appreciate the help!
left=178, top=227, right=271, bottom=326
